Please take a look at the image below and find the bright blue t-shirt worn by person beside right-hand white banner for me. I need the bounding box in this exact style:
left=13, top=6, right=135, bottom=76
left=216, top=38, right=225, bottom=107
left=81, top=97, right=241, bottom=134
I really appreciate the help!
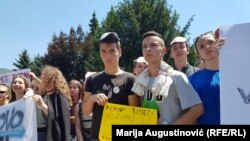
left=189, top=69, right=220, bottom=124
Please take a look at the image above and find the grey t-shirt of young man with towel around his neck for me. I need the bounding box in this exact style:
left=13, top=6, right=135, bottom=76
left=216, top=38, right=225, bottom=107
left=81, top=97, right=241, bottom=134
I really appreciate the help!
left=144, top=71, right=201, bottom=124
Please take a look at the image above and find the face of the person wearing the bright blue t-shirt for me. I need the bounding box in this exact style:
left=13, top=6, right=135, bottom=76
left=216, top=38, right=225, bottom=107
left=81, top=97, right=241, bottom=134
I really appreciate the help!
left=196, top=34, right=219, bottom=61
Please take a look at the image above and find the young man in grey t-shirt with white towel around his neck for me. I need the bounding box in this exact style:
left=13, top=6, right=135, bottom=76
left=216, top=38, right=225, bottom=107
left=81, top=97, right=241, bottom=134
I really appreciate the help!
left=132, top=31, right=203, bottom=124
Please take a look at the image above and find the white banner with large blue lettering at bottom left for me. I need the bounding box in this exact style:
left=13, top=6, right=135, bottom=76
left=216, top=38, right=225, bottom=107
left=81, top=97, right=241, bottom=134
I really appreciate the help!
left=0, top=97, right=37, bottom=141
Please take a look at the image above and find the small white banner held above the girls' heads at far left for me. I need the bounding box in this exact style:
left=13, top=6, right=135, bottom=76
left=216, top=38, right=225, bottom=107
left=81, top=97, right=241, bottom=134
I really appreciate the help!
left=0, top=68, right=30, bottom=86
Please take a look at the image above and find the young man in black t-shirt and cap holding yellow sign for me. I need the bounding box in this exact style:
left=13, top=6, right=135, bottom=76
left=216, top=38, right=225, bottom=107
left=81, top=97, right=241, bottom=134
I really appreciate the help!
left=83, top=32, right=139, bottom=140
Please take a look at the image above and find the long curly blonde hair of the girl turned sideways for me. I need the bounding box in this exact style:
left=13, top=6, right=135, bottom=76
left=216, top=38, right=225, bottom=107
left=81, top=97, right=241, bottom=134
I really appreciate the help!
left=41, top=65, right=72, bottom=105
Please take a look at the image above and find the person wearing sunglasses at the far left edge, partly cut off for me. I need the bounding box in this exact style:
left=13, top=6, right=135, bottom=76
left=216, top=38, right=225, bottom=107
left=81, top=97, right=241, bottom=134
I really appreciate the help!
left=0, top=83, right=10, bottom=106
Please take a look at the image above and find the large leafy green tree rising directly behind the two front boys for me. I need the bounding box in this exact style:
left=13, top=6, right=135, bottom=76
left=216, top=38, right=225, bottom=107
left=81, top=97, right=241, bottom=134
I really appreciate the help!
left=102, top=0, right=195, bottom=71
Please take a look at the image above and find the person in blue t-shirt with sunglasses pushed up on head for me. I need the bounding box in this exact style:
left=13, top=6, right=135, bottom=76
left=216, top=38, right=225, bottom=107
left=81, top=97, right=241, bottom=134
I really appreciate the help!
left=189, top=32, right=225, bottom=124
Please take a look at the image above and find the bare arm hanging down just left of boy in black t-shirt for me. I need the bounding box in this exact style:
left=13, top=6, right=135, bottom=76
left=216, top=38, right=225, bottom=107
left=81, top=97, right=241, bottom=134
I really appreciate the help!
left=75, top=103, right=83, bottom=141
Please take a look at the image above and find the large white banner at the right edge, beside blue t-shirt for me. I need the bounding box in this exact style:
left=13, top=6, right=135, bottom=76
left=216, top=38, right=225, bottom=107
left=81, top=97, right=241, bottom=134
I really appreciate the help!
left=219, top=23, right=250, bottom=124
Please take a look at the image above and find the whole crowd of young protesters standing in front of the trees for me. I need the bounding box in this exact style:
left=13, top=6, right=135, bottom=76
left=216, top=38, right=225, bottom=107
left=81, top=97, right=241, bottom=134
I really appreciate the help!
left=0, top=31, right=225, bottom=141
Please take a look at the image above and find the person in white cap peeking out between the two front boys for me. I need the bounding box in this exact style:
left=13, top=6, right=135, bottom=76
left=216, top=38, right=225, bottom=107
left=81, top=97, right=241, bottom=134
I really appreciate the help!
left=133, top=56, right=148, bottom=77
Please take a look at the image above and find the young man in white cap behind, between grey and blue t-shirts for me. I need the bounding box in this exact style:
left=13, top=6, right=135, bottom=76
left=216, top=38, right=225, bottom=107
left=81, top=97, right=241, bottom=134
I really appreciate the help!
left=170, top=36, right=200, bottom=77
